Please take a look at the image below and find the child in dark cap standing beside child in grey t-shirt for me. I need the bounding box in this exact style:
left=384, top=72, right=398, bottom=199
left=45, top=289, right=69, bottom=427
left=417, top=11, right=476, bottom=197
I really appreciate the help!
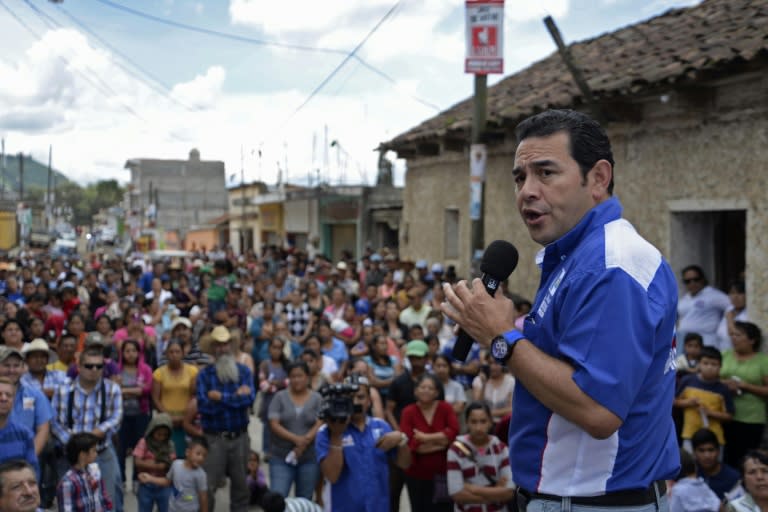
left=133, top=412, right=176, bottom=512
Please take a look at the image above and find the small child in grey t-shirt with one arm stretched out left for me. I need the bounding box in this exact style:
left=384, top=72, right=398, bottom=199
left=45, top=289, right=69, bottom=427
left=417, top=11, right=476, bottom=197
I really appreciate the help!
left=139, top=437, right=208, bottom=512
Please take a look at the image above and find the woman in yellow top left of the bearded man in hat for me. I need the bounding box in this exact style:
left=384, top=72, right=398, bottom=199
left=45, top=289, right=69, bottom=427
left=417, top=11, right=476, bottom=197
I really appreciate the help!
left=152, top=339, right=198, bottom=458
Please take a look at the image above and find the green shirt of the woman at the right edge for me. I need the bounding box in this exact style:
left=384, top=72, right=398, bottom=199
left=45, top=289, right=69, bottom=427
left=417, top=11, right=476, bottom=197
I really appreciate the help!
left=720, top=350, right=768, bottom=423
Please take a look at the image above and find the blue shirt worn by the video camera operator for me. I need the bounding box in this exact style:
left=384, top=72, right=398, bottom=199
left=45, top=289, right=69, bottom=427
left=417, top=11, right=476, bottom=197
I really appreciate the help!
left=315, top=418, right=397, bottom=512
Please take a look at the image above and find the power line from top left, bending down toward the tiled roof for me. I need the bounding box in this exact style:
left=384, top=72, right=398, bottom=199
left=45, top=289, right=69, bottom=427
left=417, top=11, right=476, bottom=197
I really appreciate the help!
left=89, top=0, right=442, bottom=112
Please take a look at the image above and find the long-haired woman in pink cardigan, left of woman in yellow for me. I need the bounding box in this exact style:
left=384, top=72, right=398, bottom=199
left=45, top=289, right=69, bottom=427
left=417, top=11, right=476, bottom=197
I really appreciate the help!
left=117, top=339, right=152, bottom=490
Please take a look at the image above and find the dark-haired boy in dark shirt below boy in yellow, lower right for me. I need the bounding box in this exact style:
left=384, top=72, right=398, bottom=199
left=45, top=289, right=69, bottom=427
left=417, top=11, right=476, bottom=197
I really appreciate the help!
left=691, top=428, right=743, bottom=501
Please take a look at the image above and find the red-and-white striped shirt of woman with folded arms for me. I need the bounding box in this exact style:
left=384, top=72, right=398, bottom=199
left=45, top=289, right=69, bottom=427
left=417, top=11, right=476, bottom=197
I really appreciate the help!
left=447, top=434, right=515, bottom=512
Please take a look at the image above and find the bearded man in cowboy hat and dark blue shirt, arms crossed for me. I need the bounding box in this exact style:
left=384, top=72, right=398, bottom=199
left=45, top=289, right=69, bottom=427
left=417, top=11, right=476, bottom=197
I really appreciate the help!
left=197, top=325, right=256, bottom=512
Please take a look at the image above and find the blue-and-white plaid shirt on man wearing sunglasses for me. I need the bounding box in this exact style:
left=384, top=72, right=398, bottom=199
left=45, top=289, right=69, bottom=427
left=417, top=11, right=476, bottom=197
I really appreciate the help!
left=51, top=377, right=123, bottom=449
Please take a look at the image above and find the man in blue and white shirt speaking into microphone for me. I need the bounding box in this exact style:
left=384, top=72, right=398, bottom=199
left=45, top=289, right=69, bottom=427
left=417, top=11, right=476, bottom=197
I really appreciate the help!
left=443, top=110, right=679, bottom=512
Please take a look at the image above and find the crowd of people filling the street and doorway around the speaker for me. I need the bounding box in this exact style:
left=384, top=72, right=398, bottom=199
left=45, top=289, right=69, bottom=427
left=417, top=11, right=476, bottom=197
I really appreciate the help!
left=0, top=244, right=768, bottom=512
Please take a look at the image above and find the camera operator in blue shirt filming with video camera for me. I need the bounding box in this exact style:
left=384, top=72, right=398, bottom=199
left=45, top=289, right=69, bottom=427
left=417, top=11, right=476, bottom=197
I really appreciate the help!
left=315, top=376, right=411, bottom=512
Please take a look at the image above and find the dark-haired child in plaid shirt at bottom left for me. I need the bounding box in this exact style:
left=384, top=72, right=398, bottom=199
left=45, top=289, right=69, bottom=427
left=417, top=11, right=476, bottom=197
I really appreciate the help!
left=56, top=432, right=112, bottom=512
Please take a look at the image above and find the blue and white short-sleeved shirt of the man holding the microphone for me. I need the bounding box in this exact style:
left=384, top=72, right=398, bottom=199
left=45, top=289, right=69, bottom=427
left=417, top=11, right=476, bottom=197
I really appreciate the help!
left=509, top=198, right=680, bottom=496
